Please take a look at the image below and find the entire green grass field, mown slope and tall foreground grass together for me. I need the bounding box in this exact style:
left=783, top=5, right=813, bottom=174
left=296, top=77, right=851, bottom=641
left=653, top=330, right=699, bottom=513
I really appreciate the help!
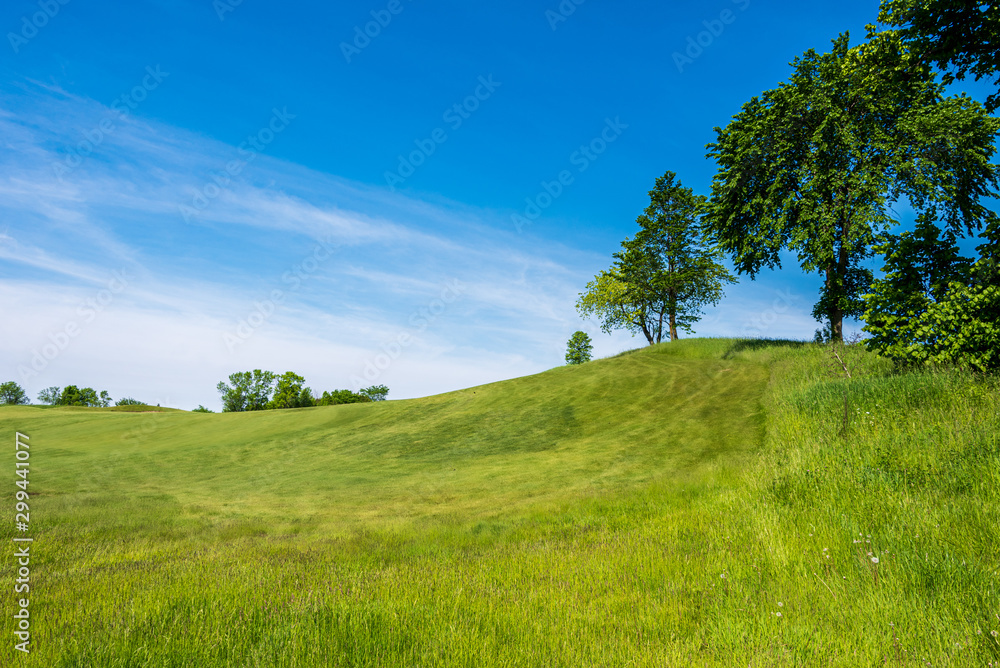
left=0, top=339, right=1000, bottom=668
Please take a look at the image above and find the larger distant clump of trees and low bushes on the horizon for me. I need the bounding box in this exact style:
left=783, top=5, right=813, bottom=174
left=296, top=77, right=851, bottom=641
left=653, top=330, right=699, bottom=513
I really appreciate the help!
left=215, top=369, right=389, bottom=413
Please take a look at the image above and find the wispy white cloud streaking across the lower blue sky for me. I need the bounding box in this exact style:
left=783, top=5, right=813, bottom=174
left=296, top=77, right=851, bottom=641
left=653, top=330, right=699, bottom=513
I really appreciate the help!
left=0, top=84, right=828, bottom=407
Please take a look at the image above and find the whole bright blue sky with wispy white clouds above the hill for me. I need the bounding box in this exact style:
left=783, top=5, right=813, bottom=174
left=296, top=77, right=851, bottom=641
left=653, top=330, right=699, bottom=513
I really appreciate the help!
left=0, top=0, right=996, bottom=408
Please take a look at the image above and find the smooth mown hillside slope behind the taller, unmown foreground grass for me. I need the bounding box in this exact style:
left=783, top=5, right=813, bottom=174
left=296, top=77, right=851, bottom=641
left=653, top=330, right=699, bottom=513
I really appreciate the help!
left=0, top=346, right=767, bottom=533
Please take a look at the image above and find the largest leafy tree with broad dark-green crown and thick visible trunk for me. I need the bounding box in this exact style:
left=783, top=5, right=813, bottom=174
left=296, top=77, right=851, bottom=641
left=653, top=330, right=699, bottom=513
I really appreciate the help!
left=707, top=32, right=1000, bottom=341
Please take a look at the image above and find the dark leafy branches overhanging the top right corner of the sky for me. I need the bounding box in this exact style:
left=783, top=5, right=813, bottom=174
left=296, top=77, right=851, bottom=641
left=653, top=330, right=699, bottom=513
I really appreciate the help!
left=878, top=0, right=1000, bottom=112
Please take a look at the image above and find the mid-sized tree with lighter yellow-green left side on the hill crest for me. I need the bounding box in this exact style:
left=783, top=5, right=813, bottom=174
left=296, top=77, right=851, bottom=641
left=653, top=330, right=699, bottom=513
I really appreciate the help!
left=577, top=171, right=735, bottom=344
